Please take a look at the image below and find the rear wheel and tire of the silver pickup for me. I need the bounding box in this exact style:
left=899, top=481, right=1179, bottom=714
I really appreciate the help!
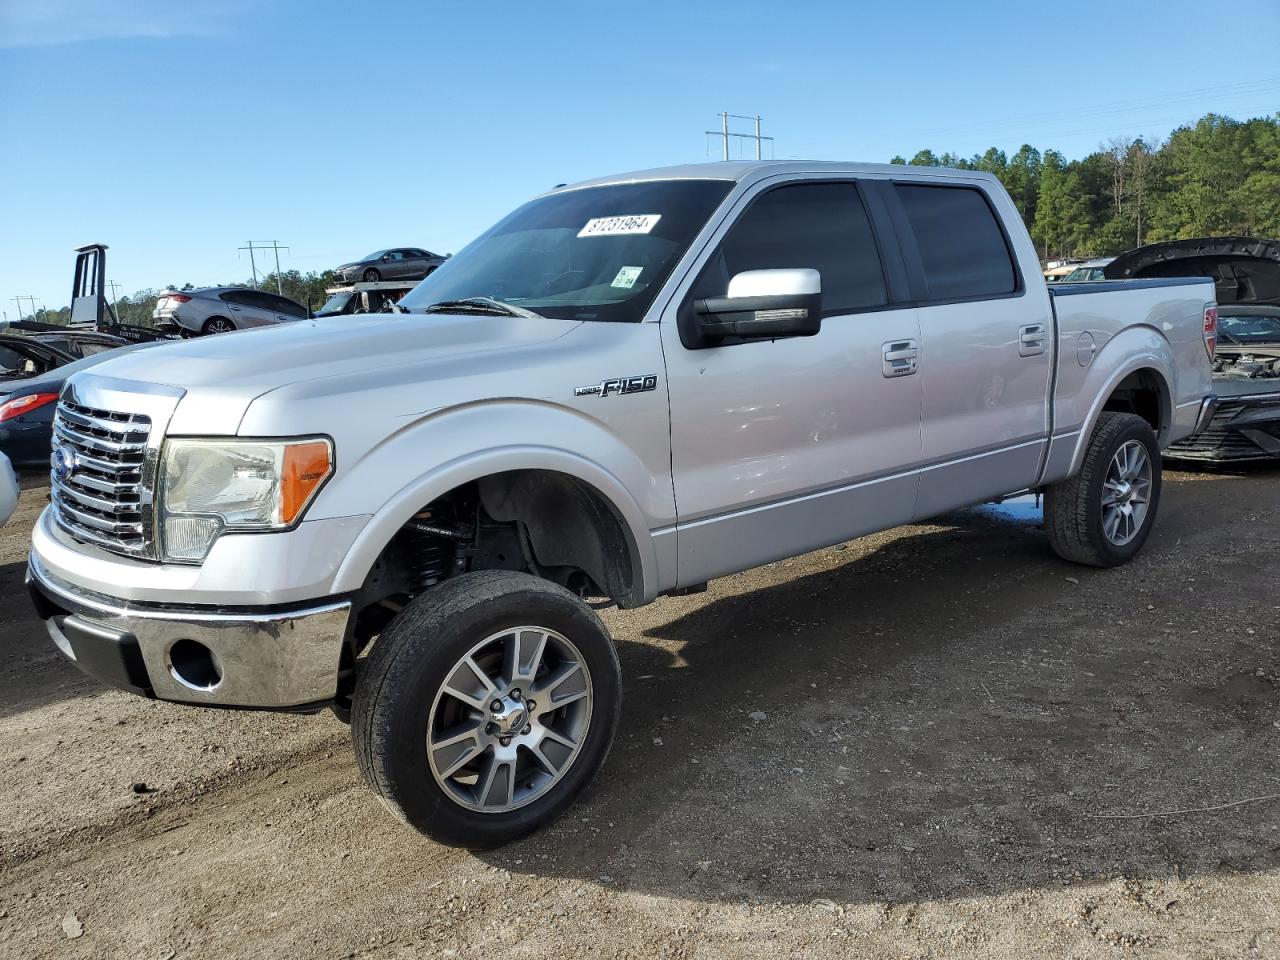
left=1044, top=412, right=1161, bottom=567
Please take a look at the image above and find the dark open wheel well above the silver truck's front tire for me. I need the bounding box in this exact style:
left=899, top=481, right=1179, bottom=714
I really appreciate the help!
left=353, top=470, right=644, bottom=649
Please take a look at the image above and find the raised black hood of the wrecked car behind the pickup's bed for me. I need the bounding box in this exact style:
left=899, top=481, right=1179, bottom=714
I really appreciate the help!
left=1103, top=237, right=1280, bottom=306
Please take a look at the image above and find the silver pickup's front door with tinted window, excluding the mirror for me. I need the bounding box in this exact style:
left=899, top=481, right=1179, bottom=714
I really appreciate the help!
left=662, top=179, right=920, bottom=585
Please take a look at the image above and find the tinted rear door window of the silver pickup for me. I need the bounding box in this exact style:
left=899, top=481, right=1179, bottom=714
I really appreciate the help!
left=895, top=183, right=1018, bottom=300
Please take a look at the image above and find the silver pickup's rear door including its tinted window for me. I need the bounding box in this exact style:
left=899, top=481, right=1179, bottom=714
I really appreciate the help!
left=886, top=180, right=1053, bottom=520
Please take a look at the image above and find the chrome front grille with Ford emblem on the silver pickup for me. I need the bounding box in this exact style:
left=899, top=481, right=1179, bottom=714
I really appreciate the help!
left=50, top=397, right=155, bottom=558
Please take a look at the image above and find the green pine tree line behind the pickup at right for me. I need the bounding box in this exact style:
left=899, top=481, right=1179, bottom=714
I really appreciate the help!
left=890, top=114, right=1280, bottom=259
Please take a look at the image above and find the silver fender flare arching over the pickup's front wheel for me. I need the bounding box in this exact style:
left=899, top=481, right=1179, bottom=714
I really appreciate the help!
left=333, top=444, right=658, bottom=603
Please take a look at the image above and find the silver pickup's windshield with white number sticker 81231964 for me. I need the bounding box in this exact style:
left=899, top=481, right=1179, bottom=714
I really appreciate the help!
left=401, top=180, right=732, bottom=323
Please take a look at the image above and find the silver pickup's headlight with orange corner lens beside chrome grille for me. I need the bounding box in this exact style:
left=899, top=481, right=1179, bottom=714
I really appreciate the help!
left=160, top=438, right=333, bottom=563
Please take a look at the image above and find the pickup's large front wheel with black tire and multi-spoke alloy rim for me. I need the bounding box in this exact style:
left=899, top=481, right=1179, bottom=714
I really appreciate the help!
left=351, top=571, right=622, bottom=850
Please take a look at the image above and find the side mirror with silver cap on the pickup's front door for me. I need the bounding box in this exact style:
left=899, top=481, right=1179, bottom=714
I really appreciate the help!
left=694, top=268, right=822, bottom=340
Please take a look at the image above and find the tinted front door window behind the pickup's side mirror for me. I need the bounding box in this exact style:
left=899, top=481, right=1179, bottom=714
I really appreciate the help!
left=699, top=183, right=888, bottom=316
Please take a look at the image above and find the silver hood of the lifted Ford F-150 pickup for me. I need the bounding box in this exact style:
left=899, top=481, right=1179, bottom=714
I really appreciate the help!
left=76, top=314, right=581, bottom=434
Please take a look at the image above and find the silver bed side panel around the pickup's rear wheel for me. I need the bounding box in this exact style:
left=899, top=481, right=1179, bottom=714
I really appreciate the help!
left=1042, top=279, right=1213, bottom=484
